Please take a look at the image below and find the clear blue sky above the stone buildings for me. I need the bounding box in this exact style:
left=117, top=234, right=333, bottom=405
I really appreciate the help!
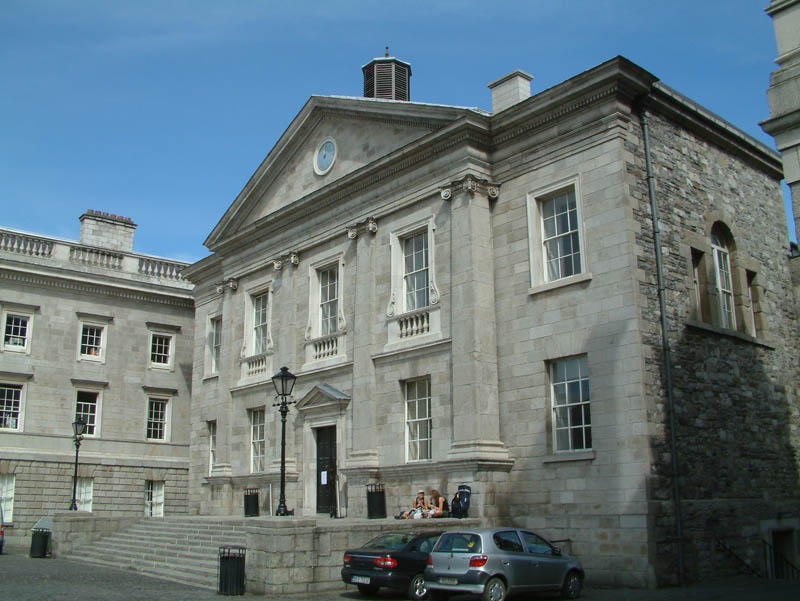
left=0, top=0, right=797, bottom=261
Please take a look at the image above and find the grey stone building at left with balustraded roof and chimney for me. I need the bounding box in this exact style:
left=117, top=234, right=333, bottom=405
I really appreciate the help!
left=0, top=211, right=194, bottom=544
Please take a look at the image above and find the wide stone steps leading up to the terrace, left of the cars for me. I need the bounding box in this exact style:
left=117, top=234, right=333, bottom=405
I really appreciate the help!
left=69, top=517, right=247, bottom=589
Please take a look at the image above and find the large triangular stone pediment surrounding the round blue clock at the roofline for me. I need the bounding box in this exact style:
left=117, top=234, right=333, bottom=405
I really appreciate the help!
left=205, top=96, right=476, bottom=251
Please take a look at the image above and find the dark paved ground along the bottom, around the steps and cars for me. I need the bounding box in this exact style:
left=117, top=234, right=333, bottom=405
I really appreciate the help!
left=0, top=547, right=800, bottom=601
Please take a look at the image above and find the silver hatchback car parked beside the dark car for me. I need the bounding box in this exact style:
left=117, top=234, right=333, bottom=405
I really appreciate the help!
left=425, top=528, right=584, bottom=601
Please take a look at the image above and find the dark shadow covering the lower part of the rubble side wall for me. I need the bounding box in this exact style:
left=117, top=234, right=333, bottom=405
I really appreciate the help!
left=650, top=326, right=800, bottom=584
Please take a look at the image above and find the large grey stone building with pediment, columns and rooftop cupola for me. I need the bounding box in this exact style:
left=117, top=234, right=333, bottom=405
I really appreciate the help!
left=184, top=57, right=800, bottom=585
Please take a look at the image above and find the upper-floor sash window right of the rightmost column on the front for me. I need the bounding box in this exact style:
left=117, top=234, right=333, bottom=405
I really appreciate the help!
left=537, top=187, right=583, bottom=282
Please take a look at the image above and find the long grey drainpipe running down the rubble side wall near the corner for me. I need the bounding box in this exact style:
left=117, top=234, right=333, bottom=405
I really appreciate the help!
left=641, top=102, right=684, bottom=584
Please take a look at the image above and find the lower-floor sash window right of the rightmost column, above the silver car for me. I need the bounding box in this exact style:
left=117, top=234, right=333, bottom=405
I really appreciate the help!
left=550, top=355, right=592, bottom=452
